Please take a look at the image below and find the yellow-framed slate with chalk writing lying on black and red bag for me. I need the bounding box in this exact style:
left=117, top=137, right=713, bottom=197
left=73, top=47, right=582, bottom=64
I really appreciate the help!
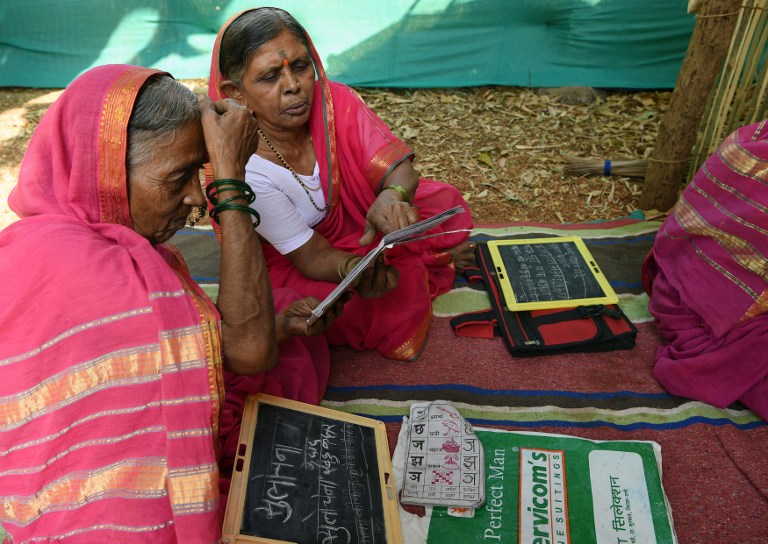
left=488, top=236, right=619, bottom=311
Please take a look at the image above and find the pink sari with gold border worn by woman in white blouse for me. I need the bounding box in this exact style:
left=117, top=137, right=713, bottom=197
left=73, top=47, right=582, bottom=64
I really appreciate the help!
left=208, top=12, right=472, bottom=360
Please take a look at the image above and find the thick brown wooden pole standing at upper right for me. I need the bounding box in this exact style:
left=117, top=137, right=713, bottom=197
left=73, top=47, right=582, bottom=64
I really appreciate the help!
left=640, top=0, right=741, bottom=211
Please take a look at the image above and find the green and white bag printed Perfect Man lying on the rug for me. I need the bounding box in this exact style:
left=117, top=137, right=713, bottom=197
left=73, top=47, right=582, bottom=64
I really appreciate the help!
left=393, top=424, right=677, bottom=544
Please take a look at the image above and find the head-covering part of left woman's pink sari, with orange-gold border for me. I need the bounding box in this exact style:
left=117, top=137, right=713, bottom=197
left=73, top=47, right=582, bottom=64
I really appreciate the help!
left=8, top=65, right=162, bottom=227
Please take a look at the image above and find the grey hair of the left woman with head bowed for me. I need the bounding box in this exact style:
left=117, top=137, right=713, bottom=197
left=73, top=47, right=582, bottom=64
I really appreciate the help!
left=125, top=74, right=201, bottom=172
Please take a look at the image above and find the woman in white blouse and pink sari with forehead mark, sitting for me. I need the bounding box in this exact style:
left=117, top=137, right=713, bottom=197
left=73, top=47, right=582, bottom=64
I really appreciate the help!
left=208, top=8, right=474, bottom=360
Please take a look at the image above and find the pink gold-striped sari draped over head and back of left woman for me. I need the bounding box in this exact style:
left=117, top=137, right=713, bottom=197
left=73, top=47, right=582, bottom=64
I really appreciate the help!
left=0, top=65, right=223, bottom=543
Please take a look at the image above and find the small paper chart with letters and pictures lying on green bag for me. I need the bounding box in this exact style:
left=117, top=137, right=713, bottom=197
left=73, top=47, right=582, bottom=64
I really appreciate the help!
left=400, top=401, right=485, bottom=508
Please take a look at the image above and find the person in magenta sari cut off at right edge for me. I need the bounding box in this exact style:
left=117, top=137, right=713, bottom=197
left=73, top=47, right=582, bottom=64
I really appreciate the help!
left=643, top=121, right=768, bottom=421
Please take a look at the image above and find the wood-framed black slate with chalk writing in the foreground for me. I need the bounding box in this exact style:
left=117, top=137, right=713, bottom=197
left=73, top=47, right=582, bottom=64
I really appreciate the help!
left=223, top=394, right=401, bottom=544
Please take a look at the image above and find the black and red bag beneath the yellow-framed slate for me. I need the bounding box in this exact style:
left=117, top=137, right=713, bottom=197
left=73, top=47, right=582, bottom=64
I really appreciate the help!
left=451, top=243, right=637, bottom=357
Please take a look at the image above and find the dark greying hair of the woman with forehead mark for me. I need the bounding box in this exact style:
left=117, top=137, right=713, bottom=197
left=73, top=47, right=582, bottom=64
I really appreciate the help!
left=219, top=8, right=309, bottom=87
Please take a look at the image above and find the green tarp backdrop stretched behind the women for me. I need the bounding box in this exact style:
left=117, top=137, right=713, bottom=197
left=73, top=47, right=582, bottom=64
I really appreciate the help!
left=0, top=0, right=694, bottom=89
